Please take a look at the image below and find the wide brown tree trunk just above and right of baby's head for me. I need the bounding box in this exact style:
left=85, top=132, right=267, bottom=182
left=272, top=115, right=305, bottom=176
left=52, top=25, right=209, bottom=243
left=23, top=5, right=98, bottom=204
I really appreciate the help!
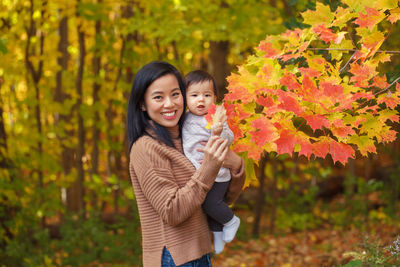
left=208, top=41, right=230, bottom=101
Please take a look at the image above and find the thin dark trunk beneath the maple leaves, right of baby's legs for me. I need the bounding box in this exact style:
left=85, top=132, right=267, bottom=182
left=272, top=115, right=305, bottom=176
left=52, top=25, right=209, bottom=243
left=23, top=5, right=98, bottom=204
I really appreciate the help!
left=252, top=156, right=267, bottom=238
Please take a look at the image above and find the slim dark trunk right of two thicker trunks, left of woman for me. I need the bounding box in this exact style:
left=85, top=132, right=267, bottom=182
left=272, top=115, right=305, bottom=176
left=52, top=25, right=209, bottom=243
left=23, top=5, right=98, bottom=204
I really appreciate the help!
left=91, top=0, right=102, bottom=214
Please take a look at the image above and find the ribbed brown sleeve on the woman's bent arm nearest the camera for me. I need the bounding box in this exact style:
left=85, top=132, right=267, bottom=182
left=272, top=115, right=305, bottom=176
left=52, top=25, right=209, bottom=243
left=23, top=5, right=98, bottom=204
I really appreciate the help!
left=131, top=139, right=218, bottom=226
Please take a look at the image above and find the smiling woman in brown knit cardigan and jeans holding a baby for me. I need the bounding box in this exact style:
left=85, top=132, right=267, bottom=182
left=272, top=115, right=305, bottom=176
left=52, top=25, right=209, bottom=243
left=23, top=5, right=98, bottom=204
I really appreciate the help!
left=128, top=61, right=245, bottom=267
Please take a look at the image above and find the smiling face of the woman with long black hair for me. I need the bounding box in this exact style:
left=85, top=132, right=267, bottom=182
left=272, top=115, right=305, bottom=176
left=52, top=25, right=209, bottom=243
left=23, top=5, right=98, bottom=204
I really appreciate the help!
left=142, top=74, right=183, bottom=128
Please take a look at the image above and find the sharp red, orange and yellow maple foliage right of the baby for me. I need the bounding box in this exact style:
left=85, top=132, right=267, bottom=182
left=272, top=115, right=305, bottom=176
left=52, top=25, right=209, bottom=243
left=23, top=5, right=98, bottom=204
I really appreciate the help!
left=209, top=0, right=400, bottom=168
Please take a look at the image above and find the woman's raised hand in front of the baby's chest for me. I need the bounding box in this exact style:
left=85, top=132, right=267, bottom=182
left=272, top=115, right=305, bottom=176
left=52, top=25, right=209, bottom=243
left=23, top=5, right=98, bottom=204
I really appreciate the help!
left=197, top=136, right=229, bottom=169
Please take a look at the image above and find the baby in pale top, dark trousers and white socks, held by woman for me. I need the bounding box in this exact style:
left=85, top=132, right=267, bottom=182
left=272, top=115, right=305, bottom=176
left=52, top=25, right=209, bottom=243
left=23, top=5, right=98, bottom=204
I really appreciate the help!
left=182, top=70, right=240, bottom=254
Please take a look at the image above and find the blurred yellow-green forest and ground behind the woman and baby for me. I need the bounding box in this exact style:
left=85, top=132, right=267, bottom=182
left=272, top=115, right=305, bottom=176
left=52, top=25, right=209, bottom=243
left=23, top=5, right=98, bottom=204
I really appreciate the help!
left=0, top=0, right=400, bottom=266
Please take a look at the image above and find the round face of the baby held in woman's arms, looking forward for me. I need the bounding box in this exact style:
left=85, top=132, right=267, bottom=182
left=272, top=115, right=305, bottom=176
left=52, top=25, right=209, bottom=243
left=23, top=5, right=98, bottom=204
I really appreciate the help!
left=186, top=81, right=216, bottom=116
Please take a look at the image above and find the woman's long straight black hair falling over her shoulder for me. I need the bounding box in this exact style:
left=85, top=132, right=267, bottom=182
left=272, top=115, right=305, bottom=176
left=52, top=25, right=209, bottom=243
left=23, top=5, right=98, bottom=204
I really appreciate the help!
left=127, top=61, right=186, bottom=151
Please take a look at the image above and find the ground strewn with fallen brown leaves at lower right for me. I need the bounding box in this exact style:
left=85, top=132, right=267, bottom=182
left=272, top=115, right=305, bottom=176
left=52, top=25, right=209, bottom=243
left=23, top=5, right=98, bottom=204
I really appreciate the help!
left=212, top=213, right=400, bottom=267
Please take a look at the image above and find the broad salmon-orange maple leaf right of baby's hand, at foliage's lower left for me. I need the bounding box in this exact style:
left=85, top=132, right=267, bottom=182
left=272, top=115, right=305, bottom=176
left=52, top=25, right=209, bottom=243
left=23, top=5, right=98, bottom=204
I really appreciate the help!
left=249, top=117, right=278, bottom=146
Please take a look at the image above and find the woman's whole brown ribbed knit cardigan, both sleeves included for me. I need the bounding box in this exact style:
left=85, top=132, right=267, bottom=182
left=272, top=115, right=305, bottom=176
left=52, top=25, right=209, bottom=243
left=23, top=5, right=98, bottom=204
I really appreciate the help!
left=129, top=127, right=245, bottom=267
